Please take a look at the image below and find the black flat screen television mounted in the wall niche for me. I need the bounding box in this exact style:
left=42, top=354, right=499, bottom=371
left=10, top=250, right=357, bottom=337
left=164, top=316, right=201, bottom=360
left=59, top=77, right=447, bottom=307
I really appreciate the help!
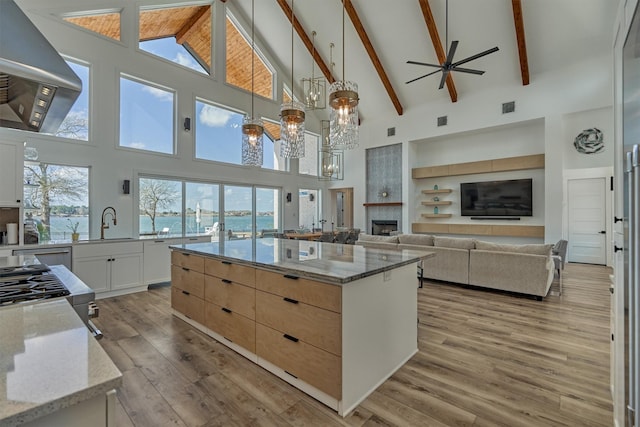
left=460, top=178, right=533, bottom=216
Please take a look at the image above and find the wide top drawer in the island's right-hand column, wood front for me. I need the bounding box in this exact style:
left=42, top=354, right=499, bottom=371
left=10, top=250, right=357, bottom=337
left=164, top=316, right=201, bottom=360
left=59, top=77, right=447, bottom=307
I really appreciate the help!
left=256, top=269, right=342, bottom=313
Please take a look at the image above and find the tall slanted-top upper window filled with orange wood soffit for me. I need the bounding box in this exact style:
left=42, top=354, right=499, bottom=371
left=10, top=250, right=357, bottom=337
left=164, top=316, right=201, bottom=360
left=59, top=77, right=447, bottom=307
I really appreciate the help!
left=225, top=16, right=274, bottom=99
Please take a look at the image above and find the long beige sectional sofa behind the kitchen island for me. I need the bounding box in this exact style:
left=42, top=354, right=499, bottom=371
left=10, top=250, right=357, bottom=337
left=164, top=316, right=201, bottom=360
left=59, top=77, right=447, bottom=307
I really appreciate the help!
left=356, top=233, right=554, bottom=299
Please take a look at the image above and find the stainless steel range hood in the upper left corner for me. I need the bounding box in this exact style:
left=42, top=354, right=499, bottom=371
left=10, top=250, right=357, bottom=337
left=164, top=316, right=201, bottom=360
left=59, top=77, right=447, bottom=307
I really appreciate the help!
left=0, top=0, right=82, bottom=133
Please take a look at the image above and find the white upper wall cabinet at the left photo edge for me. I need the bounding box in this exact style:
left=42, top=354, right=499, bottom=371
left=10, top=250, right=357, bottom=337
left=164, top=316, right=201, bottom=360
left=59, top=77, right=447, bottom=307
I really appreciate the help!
left=0, top=141, right=24, bottom=206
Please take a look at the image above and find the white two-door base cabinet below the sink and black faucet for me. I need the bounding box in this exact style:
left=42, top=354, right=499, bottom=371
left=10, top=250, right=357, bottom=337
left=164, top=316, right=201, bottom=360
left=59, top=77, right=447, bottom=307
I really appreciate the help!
left=73, top=241, right=146, bottom=298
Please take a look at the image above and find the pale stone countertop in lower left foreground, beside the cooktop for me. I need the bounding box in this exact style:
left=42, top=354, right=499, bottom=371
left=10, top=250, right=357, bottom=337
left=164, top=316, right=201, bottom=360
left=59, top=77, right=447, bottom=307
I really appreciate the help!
left=0, top=298, right=122, bottom=426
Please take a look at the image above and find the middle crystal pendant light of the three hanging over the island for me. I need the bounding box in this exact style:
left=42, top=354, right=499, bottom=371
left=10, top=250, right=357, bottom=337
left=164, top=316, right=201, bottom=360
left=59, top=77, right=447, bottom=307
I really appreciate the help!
left=280, top=0, right=305, bottom=159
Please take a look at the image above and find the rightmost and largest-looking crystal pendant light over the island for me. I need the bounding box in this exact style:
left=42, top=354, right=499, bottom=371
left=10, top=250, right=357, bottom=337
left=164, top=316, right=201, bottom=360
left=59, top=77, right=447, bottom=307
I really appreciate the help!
left=329, top=0, right=359, bottom=149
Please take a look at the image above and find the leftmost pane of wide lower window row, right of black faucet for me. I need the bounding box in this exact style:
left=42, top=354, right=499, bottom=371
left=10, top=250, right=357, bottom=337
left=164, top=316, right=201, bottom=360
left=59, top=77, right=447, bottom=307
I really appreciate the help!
left=138, top=178, right=184, bottom=236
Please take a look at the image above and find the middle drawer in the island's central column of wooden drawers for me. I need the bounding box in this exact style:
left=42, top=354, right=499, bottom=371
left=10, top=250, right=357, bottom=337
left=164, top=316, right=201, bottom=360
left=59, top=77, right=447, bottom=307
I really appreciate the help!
left=204, top=276, right=256, bottom=319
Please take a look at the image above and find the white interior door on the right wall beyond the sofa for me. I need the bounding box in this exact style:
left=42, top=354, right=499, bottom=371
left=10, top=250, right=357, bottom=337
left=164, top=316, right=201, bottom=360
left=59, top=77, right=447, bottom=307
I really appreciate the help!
left=567, top=178, right=607, bottom=265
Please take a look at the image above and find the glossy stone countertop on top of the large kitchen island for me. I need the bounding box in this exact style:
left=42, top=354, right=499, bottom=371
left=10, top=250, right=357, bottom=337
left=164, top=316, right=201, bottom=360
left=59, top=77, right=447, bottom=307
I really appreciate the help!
left=169, top=238, right=435, bottom=285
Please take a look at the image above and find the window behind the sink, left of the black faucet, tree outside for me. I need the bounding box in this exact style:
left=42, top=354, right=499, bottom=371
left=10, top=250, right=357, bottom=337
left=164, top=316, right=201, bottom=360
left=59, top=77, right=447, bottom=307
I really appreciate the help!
left=24, top=162, right=89, bottom=243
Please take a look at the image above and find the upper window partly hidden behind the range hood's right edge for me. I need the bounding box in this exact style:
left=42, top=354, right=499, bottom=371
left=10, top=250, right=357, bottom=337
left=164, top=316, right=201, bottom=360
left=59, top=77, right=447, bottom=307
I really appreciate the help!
left=55, top=60, right=89, bottom=141
